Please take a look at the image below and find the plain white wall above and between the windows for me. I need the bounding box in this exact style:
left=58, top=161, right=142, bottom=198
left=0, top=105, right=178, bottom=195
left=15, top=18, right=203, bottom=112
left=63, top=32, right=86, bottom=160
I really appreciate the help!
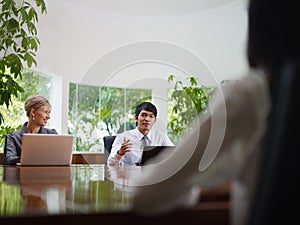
left=32, top=0, right=247, bottom=133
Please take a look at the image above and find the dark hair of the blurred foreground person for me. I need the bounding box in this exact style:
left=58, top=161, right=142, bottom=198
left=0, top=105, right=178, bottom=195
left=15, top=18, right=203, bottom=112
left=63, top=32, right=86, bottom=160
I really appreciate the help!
left=247, top=0, right=300, bottom=76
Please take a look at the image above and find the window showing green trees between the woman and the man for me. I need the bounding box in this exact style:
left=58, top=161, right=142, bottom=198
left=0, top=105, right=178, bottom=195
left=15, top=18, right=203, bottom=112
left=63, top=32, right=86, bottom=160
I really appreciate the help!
left=68, top=83, right=152, bottom=152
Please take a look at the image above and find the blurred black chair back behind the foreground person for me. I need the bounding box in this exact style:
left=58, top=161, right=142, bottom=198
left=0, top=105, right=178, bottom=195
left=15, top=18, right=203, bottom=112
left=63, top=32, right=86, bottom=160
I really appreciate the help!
left=248, top=60, right=300, bottom=225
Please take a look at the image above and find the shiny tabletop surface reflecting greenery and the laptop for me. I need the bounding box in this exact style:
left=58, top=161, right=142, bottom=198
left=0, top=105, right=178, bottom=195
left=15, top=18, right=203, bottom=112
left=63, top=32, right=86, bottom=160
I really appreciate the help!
left=0, top=164, right=140, bottom=216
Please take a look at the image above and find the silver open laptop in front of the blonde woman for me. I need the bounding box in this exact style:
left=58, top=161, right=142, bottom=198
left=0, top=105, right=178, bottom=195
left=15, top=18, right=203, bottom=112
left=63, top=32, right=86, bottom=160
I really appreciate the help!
left=17, top=133, right=74, bottom=166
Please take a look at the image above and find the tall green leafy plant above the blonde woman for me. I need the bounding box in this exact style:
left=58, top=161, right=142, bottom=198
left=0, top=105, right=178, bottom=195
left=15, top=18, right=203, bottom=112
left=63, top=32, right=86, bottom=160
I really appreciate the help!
left=0, top=0, right=46, bottom=125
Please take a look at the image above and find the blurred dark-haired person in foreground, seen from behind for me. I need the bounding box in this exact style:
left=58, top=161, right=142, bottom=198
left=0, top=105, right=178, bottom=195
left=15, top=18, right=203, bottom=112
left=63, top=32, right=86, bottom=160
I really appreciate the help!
left=132, top=0, right=300, bottom=225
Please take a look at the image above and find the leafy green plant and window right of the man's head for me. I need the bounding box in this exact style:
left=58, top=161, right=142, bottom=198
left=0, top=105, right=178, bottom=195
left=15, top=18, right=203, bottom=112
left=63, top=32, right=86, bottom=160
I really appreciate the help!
left=168, top=75, right=216, bottom=143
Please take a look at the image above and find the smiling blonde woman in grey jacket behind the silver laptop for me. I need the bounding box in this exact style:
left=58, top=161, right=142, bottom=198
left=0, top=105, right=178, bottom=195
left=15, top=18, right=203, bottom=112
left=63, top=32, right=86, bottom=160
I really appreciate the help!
left=4, top=95, right=57, bottom=165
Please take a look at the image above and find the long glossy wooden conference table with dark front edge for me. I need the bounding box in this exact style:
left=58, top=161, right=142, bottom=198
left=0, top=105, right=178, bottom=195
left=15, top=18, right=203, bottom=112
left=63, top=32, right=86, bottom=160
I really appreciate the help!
left=0, top=164, right=229, bottom=225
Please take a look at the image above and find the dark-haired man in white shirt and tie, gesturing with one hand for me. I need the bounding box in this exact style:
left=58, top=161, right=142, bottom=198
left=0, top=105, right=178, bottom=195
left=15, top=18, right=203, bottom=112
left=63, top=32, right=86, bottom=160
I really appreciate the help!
left=107, top=102, right=174, bottom=165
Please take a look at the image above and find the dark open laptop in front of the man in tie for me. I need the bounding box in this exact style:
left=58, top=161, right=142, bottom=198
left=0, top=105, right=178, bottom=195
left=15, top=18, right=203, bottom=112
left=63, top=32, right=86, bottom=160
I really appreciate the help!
left=141, top=146, right=176, bottom=165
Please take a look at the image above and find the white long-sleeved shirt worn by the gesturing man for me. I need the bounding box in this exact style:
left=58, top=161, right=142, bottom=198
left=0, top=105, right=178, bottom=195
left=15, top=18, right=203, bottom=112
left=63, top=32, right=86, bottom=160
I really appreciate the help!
left=107, top=128, right=174, bottom=165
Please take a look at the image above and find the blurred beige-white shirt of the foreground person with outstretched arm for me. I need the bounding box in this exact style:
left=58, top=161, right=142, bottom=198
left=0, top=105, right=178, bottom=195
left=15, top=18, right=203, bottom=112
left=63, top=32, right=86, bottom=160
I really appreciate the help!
left=132, top=71, right=270, bottom=225
